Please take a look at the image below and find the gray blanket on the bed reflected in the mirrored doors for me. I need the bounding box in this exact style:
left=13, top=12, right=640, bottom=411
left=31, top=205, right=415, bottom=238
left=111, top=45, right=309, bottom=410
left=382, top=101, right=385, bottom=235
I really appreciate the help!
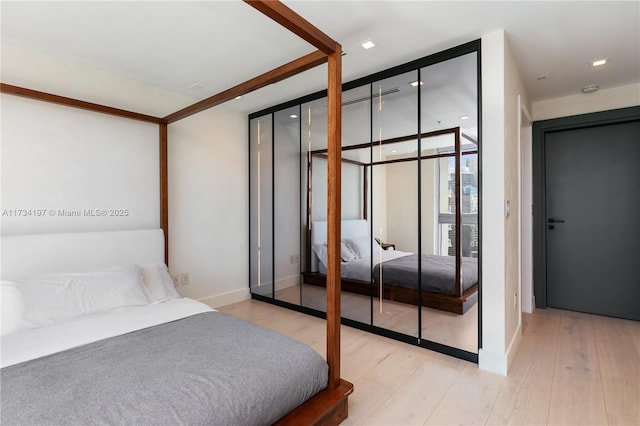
left=373, top=254, right=478, bottom=294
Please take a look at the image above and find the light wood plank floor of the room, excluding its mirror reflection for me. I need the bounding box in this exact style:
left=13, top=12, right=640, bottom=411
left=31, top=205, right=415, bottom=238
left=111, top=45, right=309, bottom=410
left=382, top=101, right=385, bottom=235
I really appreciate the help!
left=219, top=300, right=640, bottom=425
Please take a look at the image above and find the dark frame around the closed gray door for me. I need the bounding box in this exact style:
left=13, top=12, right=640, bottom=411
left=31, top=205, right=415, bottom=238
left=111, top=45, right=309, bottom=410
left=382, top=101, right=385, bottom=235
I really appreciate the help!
left=532, top=106, right=640, bottom=309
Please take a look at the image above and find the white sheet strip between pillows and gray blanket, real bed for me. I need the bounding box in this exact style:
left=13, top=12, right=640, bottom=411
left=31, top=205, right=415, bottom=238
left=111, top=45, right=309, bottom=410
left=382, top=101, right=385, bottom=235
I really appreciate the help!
left=0, top=298, right=215, bottom=368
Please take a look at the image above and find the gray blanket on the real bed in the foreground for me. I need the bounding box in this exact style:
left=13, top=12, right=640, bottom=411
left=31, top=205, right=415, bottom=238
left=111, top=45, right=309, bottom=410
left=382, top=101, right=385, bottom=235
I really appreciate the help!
left=0, top=312, right=328, bottom=426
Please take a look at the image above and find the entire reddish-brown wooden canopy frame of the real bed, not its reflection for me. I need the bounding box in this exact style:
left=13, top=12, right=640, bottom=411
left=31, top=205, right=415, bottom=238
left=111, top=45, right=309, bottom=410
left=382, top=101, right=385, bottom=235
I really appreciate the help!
left=0, top=0, right=353, bottom=425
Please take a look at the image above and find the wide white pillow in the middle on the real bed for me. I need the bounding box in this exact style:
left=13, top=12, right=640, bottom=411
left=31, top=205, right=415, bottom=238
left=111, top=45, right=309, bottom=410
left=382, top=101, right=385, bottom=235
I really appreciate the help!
left=16, top=265, right=149, bottom=328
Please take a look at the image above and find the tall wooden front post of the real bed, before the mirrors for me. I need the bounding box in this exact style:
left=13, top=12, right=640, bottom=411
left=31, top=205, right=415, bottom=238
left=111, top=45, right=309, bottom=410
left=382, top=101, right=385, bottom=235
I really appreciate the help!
left=327, top=45, right=342, bottom=388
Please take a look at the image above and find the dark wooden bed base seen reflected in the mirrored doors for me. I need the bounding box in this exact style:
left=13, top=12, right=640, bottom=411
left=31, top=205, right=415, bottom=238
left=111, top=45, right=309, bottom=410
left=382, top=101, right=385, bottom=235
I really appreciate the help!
left=302, top=272, right=478, bottom=315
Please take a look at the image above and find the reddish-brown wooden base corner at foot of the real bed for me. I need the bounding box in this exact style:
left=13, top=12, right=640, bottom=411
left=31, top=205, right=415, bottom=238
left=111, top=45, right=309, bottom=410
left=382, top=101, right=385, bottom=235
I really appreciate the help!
left=276, top=379, right=353, bottom=426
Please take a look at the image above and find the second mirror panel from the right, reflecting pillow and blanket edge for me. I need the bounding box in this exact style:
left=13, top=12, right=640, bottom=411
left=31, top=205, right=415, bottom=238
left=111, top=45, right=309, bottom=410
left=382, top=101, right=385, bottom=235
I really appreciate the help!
left=371, top=71, right=419, bottom=337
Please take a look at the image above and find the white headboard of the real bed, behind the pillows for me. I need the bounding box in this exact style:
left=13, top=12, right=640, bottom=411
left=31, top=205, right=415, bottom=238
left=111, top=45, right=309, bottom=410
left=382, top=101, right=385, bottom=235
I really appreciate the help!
left=0, top=229, right=164, bottom=280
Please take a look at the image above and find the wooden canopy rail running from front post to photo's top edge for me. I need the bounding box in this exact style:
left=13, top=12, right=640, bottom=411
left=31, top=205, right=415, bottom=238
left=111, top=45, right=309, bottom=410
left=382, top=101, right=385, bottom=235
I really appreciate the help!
left=244, top=0, right=340, bottom=55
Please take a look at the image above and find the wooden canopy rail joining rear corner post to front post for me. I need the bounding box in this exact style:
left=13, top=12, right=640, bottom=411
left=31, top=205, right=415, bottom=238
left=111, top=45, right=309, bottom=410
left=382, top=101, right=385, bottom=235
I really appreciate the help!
left=164, top=50, right=327, bottom=123
